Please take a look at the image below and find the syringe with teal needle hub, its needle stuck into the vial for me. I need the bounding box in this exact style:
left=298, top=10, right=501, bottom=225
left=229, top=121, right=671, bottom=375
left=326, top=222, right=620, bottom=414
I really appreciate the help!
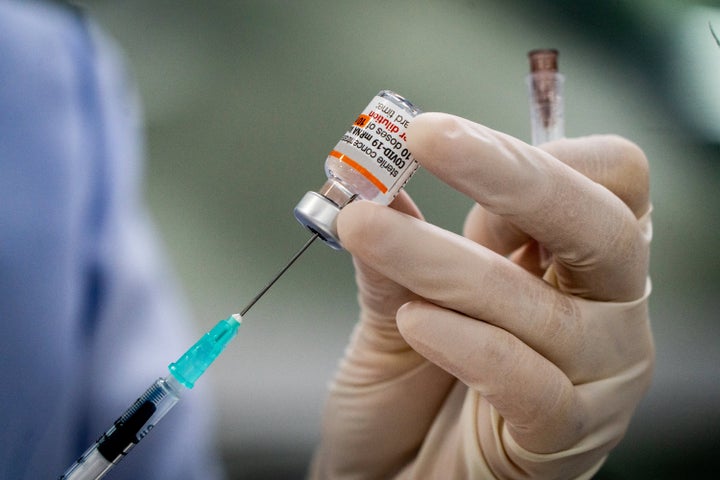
left=60, top=234, right=318, bottom=480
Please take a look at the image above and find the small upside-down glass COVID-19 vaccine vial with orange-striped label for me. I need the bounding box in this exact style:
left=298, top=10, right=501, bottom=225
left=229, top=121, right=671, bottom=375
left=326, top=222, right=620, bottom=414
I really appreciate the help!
left=295, top=90, right=420, bottom=250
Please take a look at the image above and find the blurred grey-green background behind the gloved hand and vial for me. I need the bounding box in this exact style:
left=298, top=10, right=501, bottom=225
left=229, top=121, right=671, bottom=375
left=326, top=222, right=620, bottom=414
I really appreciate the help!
left=77, top=0, right=720, bottom=479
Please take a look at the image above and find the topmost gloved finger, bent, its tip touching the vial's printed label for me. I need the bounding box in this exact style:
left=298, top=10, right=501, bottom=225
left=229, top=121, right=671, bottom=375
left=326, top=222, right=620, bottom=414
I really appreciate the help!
left=408, top=113, right=648, bottom=301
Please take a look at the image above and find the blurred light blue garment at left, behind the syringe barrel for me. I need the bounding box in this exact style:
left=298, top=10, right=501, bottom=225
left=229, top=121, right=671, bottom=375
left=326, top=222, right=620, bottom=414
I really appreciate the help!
left=0, top=0, right=218, bottom=480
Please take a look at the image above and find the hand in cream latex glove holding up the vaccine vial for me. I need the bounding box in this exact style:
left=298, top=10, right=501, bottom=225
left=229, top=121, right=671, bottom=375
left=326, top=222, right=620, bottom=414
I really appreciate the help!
left=310, top=113, right=654, bottom=479
